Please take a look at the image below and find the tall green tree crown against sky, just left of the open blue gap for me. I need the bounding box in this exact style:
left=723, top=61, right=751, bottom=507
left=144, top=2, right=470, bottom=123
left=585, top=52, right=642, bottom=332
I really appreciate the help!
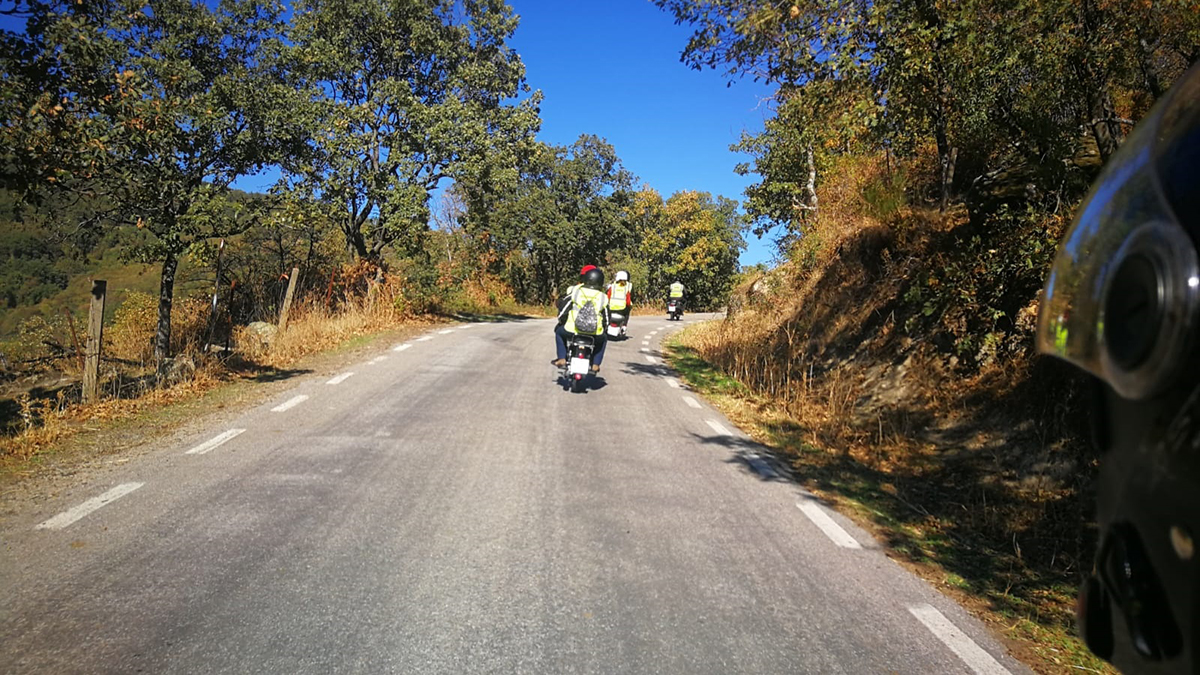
left=288, top=0, right=540, bottom=261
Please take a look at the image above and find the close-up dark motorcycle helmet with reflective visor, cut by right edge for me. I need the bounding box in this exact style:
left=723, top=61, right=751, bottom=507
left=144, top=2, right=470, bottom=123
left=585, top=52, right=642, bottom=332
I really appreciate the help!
left=1037, top=65, right=1200, bottom=673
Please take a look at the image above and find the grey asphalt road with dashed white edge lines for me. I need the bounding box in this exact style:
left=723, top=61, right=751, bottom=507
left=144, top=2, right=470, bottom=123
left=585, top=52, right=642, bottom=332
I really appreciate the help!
left=0, top=316, right=1027, bottom=674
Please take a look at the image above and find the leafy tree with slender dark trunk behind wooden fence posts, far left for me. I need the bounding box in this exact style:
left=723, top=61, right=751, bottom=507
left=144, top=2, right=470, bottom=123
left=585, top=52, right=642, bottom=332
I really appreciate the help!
left=5, top=0, right=290, bottom=365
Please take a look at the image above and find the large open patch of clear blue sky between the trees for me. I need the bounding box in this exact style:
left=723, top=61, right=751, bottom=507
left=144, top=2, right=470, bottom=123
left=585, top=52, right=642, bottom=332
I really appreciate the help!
left=509, top=0, right=772, bottom=264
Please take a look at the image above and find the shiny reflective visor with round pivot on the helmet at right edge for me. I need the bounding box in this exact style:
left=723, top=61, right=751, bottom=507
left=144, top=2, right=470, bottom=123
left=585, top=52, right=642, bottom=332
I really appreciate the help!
left=1036, top=68, right=1200, bottom=399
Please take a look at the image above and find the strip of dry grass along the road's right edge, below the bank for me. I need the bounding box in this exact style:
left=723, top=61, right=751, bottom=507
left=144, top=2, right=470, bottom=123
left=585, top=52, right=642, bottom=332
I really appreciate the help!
left=665, top=323, right=1115, bottom=673
